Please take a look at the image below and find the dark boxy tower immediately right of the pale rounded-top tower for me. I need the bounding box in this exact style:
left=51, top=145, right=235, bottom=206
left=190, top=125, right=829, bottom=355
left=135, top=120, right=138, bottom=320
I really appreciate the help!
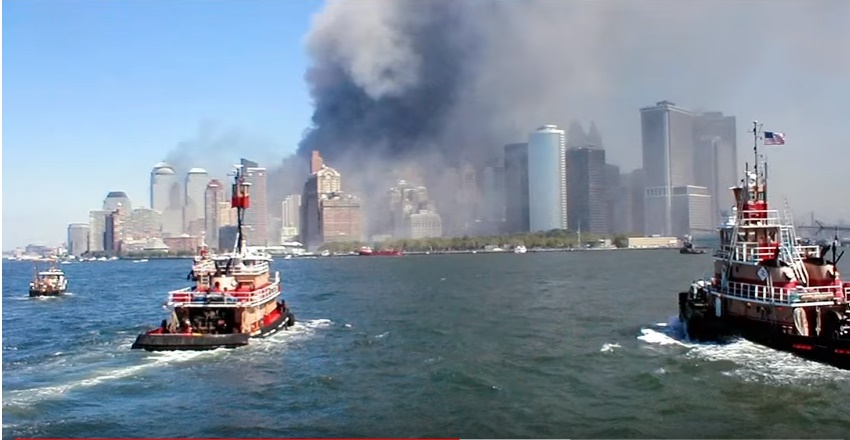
left=567, top=146, right=609, bottom=234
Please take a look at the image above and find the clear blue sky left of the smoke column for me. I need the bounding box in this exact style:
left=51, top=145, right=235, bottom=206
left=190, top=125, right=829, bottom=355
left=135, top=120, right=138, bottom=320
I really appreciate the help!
left=2, top=0, right=321, bottom=250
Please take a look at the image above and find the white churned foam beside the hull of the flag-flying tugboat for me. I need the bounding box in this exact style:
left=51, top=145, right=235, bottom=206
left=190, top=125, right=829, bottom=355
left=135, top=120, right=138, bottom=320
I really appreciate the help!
left=637, top=317, right=850, bottom=384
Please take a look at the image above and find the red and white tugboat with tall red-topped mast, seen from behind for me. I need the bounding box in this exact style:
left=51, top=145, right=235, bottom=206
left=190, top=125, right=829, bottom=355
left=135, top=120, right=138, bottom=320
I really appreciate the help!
left=132, top=166, right=295, bottom=351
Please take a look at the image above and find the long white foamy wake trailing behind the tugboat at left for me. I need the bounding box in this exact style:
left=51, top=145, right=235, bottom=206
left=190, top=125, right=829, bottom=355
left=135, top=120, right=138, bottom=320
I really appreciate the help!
left=3, top=319, right=332, bottom=410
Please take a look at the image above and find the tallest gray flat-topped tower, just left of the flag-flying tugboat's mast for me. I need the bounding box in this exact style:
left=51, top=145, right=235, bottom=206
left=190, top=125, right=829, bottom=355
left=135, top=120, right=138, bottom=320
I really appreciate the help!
left=640, top=101, right=694, bottom=236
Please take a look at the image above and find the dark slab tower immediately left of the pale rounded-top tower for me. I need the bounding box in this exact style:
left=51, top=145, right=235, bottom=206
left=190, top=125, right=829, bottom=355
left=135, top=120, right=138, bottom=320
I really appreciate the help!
left=505, top=143, right=529, bottom=233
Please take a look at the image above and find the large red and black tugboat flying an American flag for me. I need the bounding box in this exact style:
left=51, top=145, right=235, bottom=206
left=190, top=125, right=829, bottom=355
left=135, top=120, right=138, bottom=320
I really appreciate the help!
left=679, top=122, right=850, bottom=369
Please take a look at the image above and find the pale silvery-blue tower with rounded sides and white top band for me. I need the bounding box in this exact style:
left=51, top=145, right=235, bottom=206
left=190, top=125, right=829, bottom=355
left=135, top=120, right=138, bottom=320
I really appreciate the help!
left=528, top=125, right=568, bottom=232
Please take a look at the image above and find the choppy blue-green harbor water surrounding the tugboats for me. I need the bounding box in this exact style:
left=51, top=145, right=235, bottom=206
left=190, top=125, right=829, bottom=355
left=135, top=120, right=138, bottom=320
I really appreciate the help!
left=2, top=251, right=850, bottom=438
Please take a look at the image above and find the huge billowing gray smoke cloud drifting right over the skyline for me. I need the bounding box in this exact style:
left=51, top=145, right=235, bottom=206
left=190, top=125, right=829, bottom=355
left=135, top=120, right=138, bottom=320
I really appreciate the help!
left=274, top=0, right=850, bottom=223
